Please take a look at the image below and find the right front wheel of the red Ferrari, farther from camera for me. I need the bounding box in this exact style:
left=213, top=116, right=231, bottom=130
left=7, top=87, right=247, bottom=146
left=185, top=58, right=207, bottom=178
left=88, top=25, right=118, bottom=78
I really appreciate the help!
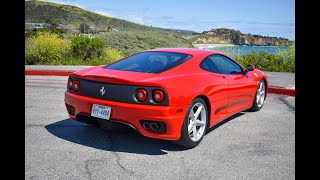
left=249, top=79, right=266, bottom=111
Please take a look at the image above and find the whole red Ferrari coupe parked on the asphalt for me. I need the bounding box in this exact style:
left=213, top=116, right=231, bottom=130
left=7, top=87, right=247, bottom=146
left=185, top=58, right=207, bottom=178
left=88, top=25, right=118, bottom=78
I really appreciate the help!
left=65, top=48, right=268, bottom=148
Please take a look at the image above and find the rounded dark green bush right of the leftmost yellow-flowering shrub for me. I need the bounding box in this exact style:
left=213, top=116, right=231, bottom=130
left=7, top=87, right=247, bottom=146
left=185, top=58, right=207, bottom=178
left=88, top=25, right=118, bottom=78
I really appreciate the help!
left=71, top=36, right=105, bottom=60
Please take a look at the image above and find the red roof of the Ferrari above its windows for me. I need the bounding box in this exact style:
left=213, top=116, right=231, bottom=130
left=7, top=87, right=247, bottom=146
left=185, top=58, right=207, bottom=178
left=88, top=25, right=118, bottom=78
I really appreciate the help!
left=146, top=48, right=221, bottom=55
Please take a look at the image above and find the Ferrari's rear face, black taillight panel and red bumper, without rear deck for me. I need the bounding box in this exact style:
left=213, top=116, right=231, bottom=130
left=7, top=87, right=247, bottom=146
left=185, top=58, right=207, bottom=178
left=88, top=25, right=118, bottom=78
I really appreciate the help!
left=65, top=76, right=188, bottom=140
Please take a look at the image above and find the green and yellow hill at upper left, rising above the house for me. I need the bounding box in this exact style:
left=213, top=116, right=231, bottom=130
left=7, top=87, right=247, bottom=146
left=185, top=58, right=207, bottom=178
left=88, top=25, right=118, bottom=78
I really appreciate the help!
left=25, top=1, right=164, bottom=31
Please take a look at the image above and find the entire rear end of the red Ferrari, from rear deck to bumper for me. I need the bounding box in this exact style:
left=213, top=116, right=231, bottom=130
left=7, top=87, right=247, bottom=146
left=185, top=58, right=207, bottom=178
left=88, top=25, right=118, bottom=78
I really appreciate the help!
left=65, top=50, right=194, bottom=140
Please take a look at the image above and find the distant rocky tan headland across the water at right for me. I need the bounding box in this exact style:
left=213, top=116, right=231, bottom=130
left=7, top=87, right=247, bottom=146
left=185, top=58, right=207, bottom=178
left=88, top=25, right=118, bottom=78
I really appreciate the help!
left=191, top=28, right=292, bottom=46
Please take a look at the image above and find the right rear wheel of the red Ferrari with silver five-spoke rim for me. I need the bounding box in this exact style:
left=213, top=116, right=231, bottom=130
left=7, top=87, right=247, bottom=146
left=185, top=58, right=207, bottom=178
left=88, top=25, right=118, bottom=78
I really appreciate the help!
left=172, top=98, right=208, bottom=148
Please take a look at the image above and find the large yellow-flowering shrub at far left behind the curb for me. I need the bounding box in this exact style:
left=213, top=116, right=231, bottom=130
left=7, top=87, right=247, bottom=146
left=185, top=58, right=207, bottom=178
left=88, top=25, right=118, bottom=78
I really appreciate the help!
left=25, top=32, right=70, bottom=64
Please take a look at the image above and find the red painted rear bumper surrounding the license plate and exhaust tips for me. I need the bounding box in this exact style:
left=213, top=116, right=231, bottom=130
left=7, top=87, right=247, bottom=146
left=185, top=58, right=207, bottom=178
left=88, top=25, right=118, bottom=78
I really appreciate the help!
left=64, top=91, right=188, bottom=140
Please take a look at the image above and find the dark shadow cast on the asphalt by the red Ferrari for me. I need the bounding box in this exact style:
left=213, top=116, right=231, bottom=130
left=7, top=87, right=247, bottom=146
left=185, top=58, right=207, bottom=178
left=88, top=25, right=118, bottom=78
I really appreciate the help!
left=45, top=113, right=242, bottom=155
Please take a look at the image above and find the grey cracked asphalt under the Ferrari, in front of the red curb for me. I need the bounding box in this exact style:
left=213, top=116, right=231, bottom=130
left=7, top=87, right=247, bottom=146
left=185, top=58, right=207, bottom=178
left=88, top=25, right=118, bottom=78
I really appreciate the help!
left=25, top=76, right=295, bottom=180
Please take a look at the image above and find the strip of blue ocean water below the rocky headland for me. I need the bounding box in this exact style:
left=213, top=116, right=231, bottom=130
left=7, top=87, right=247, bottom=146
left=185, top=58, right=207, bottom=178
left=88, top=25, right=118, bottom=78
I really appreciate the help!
left=199, top=46, right=289, bottom=56
